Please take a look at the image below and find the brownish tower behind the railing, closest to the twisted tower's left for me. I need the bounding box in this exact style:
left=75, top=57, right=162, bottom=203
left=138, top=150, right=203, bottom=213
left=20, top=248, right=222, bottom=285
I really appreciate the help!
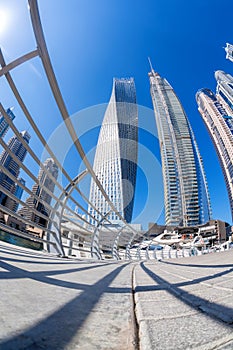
left=19, top=158, right=58, bottom=227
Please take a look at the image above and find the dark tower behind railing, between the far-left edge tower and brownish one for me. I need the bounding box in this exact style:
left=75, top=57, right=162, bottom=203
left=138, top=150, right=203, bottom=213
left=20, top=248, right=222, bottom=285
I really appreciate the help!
left=0, top=131, right=31, bottom=210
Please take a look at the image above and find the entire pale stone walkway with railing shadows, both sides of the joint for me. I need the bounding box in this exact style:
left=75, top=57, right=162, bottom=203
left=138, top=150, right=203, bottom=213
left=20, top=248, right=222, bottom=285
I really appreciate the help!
left=0, top=242, right=233, bottom=350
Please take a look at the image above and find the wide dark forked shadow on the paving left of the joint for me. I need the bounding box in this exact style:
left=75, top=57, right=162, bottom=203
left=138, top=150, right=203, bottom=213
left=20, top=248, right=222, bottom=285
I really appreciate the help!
left=0, top=263, right=128, bottom=350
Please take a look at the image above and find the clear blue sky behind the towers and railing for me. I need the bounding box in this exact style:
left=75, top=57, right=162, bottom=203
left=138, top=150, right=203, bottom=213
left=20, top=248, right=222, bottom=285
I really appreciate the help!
left=0, top=0, right=233, bottom=224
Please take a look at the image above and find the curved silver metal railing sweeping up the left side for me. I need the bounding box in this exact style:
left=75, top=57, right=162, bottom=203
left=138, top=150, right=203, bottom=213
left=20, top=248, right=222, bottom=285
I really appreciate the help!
left=0, top=0, right=149, bottom=259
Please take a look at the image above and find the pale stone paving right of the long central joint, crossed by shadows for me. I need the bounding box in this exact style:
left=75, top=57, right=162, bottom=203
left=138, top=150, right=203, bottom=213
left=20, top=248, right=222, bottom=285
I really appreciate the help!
left=134, top=251, right=233, bottom=350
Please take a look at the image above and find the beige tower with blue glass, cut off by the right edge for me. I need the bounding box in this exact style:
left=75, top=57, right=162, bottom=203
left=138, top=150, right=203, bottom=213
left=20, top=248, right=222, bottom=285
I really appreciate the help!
left=196, top=86, right=233, bottom=218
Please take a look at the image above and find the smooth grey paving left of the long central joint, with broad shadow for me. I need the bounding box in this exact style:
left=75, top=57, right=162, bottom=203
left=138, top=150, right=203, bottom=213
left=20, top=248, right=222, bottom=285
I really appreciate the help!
left=0, top=242, right=135, bottom=350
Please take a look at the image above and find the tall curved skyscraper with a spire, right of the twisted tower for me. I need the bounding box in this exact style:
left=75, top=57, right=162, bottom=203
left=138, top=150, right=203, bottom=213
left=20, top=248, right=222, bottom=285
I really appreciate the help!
left=149, top=69, right=211, bottom=226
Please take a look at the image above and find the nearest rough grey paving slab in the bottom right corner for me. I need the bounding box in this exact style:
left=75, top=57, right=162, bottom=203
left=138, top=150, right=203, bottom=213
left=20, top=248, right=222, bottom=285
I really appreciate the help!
left=139, top=314, right=233, bottom=350
